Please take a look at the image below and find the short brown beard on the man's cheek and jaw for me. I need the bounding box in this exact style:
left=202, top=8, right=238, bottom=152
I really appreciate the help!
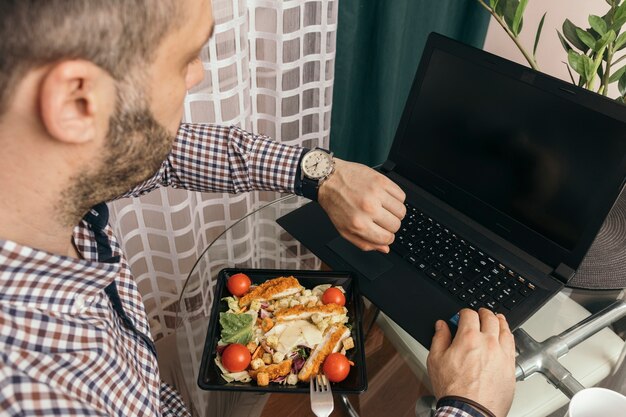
left=61, top=75, right=174, bottom=226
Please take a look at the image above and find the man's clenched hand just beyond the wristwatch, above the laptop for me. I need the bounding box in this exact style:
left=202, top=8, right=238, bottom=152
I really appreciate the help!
left=318, top=158, right=406, bottom=253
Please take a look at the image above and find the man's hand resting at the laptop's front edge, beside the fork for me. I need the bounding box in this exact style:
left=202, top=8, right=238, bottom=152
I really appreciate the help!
left=428, top=308, right=515, bottom=417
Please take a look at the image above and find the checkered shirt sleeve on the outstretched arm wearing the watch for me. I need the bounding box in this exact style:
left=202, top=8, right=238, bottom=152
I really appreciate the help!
left=122, top=124, right=303, bottom=197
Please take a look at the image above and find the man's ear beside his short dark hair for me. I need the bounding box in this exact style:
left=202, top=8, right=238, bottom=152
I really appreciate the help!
left=39, top=60, right=115, bottom=144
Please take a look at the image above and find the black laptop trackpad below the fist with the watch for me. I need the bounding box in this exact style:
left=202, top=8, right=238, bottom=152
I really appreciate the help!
left=326, top=236, right=393, bottom=281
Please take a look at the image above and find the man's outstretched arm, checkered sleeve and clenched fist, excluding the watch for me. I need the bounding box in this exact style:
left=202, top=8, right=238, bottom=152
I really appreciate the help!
left=122, top=124, right=406, bottom=252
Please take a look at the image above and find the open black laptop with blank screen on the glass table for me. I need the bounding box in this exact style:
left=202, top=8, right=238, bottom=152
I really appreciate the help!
left=278, top=33, right=626, bottom=347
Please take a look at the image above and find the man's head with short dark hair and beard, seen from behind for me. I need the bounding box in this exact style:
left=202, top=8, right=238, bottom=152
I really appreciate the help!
left=0, top=0, right=213, bottom=222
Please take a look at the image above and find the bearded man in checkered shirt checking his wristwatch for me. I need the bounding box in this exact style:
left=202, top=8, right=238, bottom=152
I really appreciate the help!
left=0, top=0, right=512, bottom=416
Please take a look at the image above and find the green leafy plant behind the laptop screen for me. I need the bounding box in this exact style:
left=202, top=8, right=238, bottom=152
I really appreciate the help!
left=477, top=0, right=626, bottom=103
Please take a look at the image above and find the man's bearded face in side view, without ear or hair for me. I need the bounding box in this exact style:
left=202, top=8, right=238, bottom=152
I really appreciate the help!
left=63, top=0, right=213, bottom=224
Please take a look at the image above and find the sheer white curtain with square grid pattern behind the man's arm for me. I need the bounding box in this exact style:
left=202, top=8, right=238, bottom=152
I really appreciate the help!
left=110, top=0, right=338, bottom=339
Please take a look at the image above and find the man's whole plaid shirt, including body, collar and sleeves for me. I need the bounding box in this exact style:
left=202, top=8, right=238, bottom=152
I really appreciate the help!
left=0, top=124, right=473, bottom=417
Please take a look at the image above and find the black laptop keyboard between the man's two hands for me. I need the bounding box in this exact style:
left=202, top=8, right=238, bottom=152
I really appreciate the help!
left=391, top=204, right=536, bottom=313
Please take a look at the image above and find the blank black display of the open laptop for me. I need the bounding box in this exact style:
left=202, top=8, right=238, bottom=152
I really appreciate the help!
left=392, top=50, right=626, bottom=250
